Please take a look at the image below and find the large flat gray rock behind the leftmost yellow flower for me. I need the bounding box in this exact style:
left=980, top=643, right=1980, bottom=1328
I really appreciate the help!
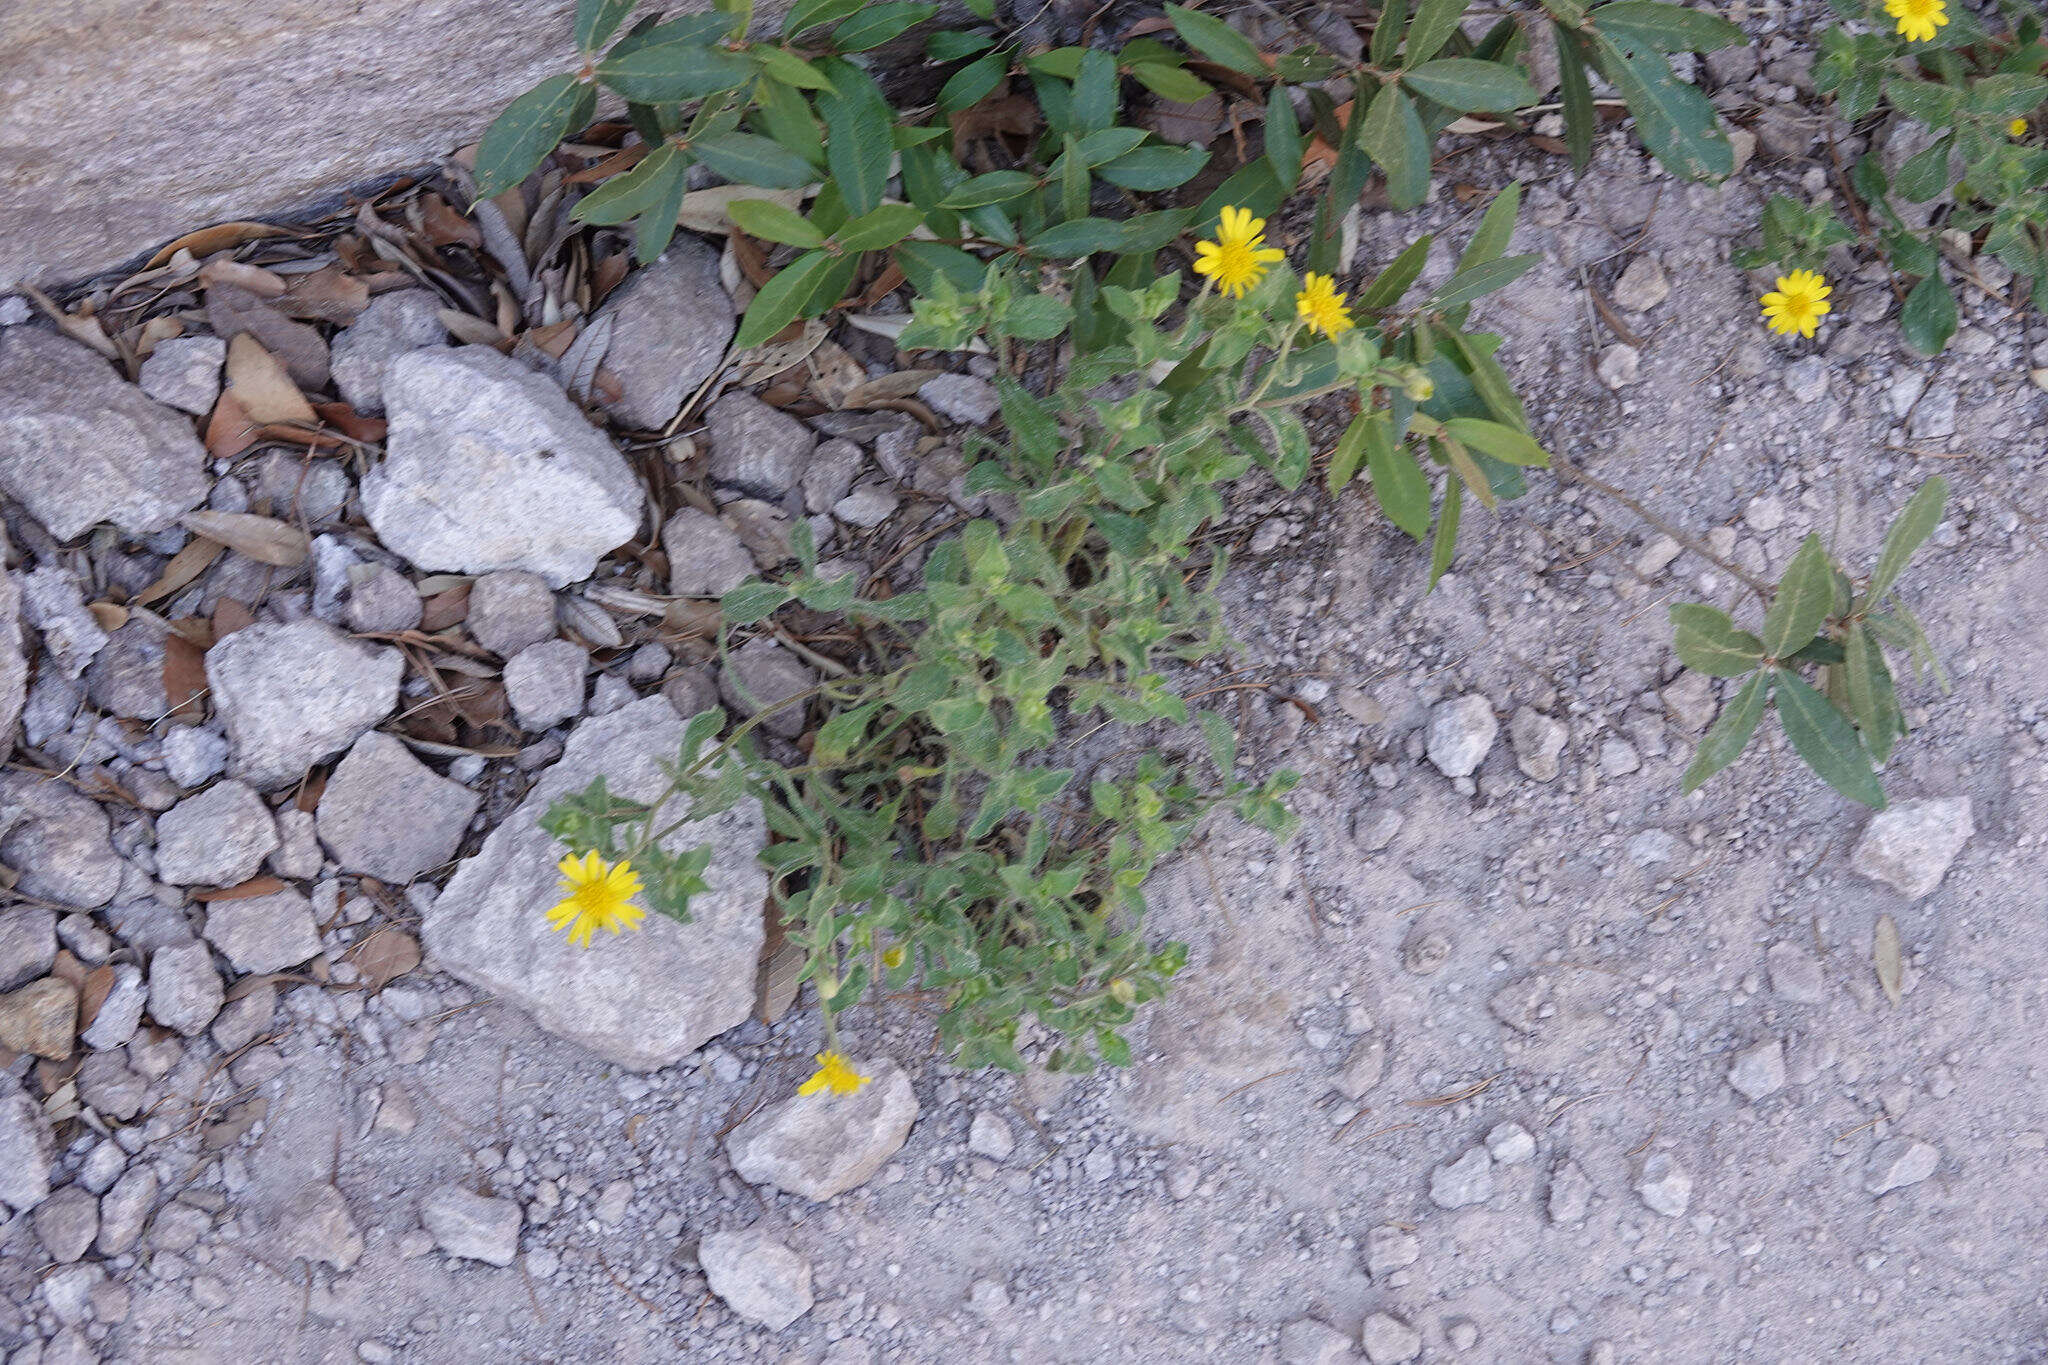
left=422, top=698, right=768, bottom=1070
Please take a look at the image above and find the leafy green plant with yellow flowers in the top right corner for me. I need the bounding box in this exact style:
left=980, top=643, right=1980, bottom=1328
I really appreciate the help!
left=1737, top=0, right=2048, bottom=356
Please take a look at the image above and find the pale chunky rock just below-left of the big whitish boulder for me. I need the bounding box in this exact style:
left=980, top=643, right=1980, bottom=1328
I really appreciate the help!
left=207, top=620, right=406, bottom=792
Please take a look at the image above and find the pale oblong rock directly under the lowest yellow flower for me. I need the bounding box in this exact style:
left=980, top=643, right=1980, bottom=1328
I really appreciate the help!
left=725, top=1056, right=918, bottom=1199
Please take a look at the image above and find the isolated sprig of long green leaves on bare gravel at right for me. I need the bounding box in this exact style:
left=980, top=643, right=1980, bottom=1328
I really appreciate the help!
left=1671, top=477, right=1948, bottom=808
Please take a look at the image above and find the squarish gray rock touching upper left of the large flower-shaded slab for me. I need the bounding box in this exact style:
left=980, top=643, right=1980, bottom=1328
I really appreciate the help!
left=319, top=732, right=479, bottom=886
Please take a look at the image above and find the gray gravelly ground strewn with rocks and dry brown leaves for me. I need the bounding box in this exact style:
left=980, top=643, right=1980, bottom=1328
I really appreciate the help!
left=0, top=20, right=2048, bottom=1365
